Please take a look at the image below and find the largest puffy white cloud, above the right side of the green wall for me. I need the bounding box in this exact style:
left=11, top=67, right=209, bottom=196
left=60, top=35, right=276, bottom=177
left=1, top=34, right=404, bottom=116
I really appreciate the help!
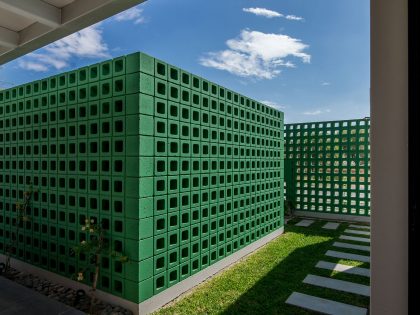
left=200, top=30, right=311, bottom=79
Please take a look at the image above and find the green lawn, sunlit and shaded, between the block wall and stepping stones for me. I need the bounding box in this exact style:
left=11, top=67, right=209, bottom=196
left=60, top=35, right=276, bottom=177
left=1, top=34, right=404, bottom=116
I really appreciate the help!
left=155, top=221, right=369, bottom=315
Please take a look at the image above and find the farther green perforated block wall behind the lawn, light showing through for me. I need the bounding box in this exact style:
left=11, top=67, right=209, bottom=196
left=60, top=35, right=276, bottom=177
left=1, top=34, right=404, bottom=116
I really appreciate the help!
left=284, top=118, right=370, bottom=216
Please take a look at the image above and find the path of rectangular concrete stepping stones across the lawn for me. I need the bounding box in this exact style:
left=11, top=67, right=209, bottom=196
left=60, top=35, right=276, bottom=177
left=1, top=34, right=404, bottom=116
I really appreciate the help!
left=286, top=220, right=370, bottom=315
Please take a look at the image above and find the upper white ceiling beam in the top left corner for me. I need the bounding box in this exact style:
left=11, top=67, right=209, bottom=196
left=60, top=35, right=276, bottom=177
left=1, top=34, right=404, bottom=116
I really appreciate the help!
left=0, top=0, right=61, bottom=27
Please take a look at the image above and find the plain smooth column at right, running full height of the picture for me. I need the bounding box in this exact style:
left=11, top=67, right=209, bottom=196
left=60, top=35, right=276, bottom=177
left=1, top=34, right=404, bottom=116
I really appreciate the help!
left=371, top=0, right=408, bottom=315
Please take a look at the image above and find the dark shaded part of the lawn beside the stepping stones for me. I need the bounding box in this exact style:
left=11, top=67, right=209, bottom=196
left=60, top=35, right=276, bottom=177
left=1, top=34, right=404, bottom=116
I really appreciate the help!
left=221, top=221, right=369, bottom=315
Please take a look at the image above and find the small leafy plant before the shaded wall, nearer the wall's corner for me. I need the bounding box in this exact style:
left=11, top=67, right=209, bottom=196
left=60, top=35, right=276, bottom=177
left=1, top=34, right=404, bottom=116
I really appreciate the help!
left=73, top=218, right=128, bottom=314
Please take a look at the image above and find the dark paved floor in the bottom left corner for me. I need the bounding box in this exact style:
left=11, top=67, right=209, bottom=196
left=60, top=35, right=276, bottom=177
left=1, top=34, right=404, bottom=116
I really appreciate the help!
left=0, top=276, right=85, bottom=315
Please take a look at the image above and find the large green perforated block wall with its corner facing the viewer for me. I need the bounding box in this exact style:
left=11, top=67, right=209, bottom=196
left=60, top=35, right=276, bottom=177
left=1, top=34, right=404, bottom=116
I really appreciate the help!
left=0, top=53, right=284, bottom=303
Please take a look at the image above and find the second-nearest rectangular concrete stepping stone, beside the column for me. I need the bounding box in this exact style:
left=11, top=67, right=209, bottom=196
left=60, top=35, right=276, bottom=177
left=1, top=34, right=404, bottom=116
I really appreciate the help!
left=303, top=274, right=370, bottom=296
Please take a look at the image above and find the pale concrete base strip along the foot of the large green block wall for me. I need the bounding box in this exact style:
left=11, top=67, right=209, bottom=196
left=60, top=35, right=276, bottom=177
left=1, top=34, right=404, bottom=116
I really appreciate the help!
left=0, top=227, right=284, bottom=315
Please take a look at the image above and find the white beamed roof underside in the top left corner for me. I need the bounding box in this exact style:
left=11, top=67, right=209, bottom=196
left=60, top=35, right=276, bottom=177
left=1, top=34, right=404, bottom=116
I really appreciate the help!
left=0, top=0, right=145, bottom=64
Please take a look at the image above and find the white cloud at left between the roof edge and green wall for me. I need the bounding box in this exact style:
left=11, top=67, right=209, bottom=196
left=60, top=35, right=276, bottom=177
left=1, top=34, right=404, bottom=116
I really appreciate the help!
left=18, top=23, right=109, bottom=71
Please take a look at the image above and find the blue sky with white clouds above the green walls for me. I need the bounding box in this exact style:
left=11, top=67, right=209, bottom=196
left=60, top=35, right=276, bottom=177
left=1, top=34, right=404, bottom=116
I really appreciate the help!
left=0, top=0, right=370, bottom=122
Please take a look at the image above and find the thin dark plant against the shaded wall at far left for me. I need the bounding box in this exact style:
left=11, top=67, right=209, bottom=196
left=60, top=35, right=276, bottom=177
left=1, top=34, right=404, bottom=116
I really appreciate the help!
left=3, top=184, right=35, bottom=273
